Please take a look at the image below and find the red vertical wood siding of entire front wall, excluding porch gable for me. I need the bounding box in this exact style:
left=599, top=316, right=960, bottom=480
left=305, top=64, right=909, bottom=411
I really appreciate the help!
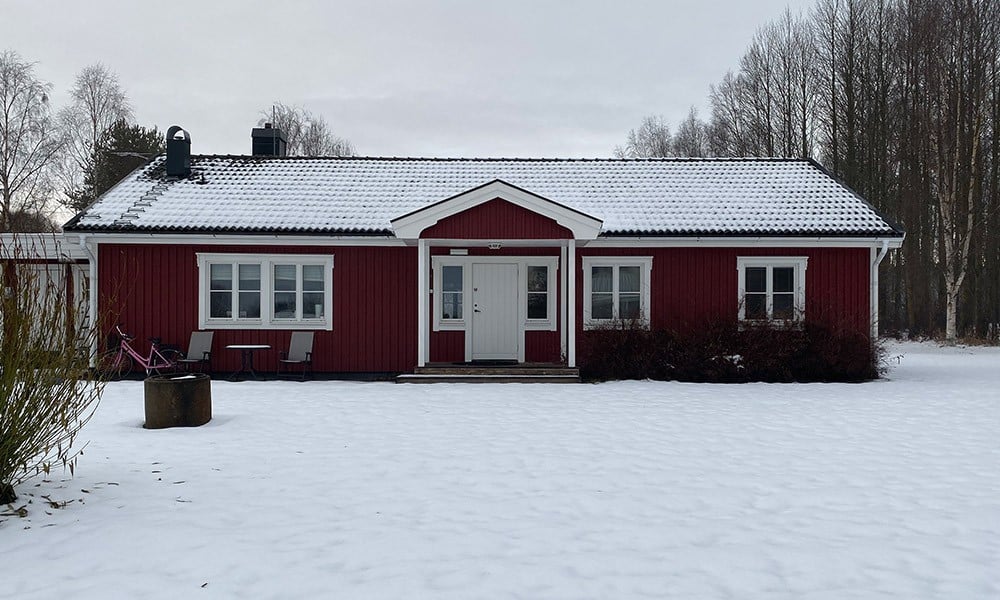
left=96, top=244, right=870, bottom=372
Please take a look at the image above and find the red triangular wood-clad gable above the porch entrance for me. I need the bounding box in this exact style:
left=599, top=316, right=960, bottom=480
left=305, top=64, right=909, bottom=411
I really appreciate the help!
left=420, top=198, right=573, bottom=240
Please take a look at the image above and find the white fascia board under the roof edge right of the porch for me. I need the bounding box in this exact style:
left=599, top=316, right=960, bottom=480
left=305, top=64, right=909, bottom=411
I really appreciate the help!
left=580, top=236, right=903, bottom=249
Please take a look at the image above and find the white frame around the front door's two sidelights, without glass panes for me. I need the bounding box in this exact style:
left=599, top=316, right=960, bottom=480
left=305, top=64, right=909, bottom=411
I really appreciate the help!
left=431, top=255, right=559, bottom=331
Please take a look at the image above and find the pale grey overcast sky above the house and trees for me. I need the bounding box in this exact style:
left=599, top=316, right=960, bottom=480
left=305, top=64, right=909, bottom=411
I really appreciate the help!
left=0, top=0, right=813, bottom=157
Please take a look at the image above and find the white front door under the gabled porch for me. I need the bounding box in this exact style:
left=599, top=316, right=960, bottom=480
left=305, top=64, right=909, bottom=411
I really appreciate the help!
left=472, top=263, right=519, bottom=360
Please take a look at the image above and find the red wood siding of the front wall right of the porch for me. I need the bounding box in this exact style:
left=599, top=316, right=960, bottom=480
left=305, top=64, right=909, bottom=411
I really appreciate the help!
left=576, top=248, right=870, bottom=333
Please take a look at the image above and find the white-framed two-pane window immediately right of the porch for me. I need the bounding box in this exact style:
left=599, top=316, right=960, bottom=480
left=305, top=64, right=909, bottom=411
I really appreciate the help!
left=583, top=256, right=653, bottom=328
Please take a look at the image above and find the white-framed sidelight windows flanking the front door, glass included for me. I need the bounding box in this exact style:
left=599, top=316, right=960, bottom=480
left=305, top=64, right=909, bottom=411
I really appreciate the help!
left=431, top=255, right=559, bottom=331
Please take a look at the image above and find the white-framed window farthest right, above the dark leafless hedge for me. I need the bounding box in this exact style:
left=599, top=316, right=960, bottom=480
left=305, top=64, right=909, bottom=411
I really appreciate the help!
left=736, top=256, right=809, bottom=322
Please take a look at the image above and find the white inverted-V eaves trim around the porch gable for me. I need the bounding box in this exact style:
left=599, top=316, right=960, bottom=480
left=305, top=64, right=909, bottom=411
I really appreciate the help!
left=391, top=179, right=604, bottom=240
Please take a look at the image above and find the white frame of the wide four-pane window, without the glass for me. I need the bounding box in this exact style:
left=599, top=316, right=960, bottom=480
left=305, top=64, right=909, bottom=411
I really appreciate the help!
left=197, top=252, right=333, bottom=331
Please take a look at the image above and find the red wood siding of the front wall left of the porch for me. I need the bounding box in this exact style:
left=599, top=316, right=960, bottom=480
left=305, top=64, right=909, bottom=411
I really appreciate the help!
left=98, top=244, right=417, bottom=372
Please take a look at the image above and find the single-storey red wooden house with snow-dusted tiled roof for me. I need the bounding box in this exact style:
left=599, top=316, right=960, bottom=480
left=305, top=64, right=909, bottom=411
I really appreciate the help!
left=64, top=128, right=903, bottom=373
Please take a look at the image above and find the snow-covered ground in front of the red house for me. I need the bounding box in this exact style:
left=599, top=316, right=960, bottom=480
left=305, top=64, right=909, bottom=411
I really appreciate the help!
left=0, top=344, right=1000, bottom=599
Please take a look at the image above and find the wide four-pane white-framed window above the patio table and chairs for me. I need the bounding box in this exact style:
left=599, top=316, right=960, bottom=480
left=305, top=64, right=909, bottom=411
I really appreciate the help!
left=198, top=253, right=333, bottom=330
